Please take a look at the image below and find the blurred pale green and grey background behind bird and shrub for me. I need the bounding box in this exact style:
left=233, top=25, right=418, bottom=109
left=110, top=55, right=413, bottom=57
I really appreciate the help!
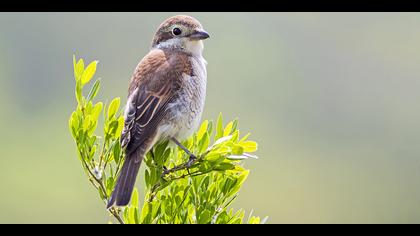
left=0, top=13, right=420, bottom=223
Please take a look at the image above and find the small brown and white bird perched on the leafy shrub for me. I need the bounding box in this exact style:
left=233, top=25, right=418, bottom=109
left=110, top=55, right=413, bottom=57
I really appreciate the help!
left=107, top=15, right=210, bottom=208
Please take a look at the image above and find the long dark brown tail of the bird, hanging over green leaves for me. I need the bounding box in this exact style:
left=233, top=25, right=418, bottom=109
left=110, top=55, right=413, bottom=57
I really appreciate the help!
left=107, top=148, right=144, bottom=208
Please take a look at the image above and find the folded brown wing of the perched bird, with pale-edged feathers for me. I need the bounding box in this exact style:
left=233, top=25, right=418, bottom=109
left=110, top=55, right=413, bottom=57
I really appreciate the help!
left=121, top=51, right=182, bottom=156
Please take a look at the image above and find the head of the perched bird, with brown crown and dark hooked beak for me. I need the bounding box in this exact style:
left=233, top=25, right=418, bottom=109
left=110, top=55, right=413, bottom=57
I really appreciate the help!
left=152, top=15, right=210, bottom=55
